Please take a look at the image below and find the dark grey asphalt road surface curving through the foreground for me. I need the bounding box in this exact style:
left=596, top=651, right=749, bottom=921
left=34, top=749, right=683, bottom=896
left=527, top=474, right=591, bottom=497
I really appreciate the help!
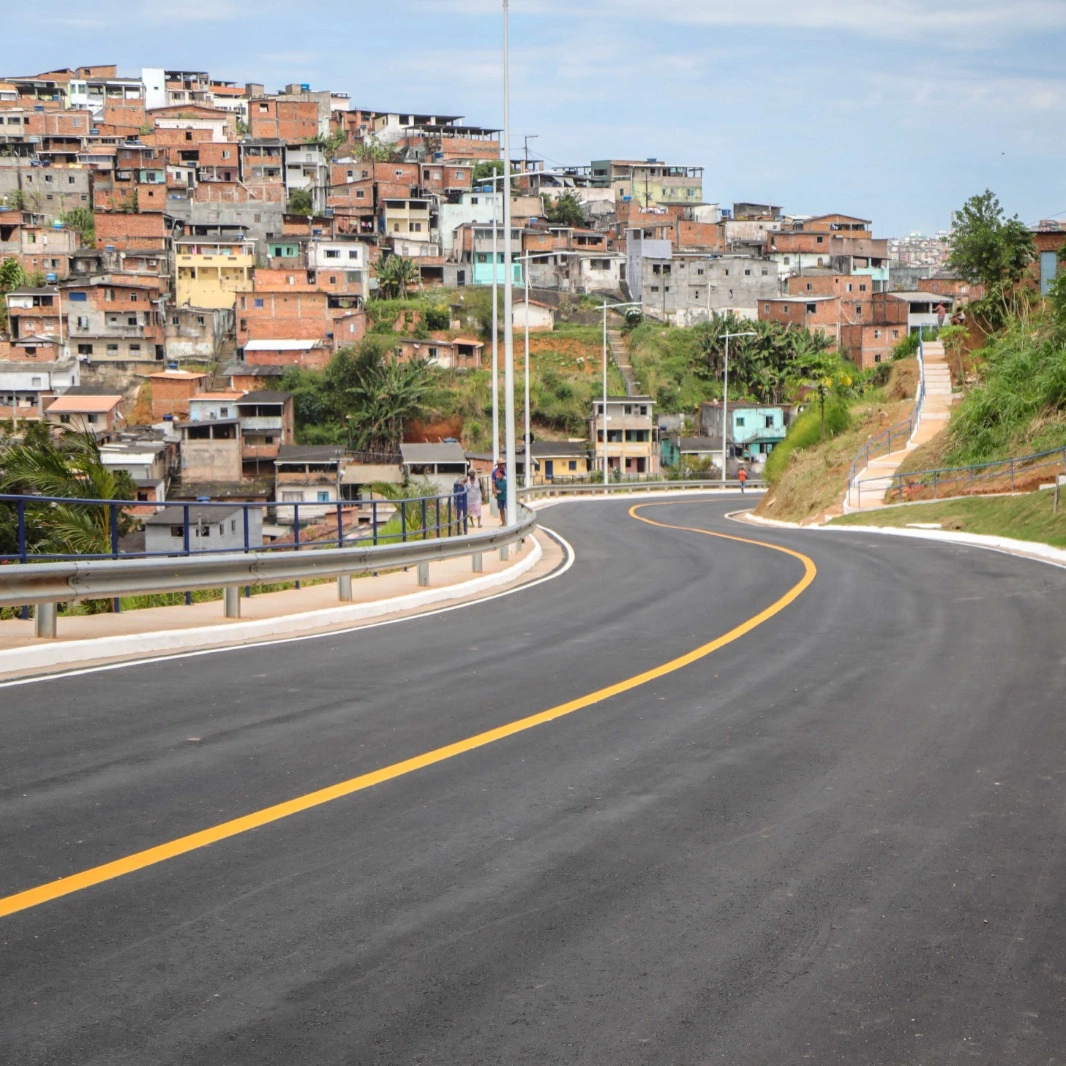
left=0, top=498, right=1066, bottom=1066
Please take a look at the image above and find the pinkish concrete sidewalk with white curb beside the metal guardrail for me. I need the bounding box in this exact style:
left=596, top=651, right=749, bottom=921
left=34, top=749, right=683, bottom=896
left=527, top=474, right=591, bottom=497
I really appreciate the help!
left=0, top=516, right=564, bottom=680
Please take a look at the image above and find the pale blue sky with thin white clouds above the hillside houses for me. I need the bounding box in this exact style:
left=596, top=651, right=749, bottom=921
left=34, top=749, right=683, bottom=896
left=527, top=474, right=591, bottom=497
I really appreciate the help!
left=8, top=0, right=1066, bottom=237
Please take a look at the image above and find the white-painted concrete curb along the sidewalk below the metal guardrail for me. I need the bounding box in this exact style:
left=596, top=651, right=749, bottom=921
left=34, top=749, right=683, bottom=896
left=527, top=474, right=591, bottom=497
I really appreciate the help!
left=0, top=536, right=544, bottom=676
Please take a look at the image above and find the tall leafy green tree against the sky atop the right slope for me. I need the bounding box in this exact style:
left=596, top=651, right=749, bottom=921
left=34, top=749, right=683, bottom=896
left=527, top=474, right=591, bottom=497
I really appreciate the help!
left=948, top=189, right=1036, bottom=313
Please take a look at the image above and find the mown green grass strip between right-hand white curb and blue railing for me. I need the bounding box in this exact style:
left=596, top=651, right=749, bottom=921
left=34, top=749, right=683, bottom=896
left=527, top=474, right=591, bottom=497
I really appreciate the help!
left=830, top=491, right=1066, bottom=548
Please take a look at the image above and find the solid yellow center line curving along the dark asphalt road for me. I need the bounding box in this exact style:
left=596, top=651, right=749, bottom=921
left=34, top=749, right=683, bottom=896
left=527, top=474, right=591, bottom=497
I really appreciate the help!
left=0, top=503, right=818, bottom=918
